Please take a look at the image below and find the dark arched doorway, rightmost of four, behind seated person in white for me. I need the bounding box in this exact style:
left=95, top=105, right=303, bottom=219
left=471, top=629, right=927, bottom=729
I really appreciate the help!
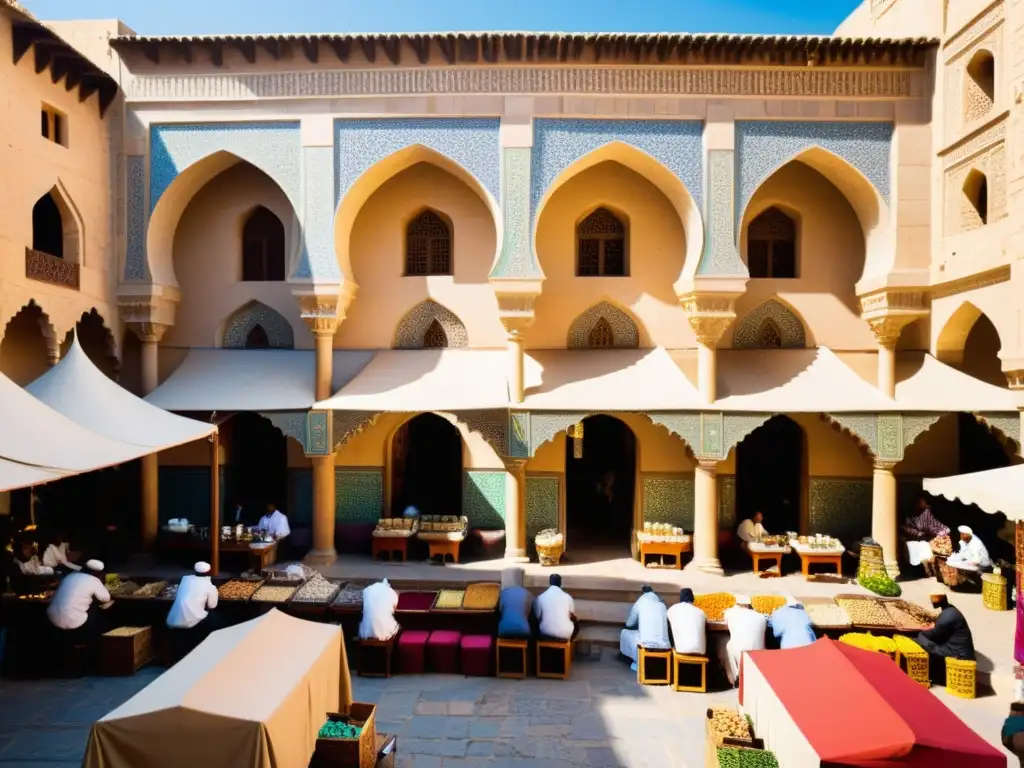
left=736, top=416, right=806, bottom=534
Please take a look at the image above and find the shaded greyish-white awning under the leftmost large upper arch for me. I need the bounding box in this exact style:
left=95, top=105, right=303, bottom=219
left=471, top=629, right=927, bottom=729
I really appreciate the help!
left=145, top=349, right=374, bottom=411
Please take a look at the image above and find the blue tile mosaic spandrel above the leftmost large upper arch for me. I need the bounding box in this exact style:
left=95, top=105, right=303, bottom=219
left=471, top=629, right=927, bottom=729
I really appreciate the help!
left=150, top=123, right=302, bottom=211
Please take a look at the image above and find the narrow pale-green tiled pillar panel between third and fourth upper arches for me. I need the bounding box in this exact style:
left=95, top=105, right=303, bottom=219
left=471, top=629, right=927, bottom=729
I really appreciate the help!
left=697, top=150, right=749, bottom=276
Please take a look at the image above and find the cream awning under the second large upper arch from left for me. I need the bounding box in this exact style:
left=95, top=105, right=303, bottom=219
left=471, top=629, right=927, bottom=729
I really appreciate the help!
left=316, top=349, right=509, bottom=413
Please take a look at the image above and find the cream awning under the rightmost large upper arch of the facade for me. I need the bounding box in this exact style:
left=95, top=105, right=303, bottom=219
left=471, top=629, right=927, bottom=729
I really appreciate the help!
left=715, top=347, right=898, bottom=413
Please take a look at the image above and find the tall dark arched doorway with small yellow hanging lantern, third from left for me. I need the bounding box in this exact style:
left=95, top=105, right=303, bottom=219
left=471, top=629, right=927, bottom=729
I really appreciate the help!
left=565, top=416, right=637, bottom=553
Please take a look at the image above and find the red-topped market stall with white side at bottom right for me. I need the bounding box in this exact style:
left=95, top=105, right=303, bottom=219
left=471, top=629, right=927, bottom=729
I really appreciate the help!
left=739, top=639, right=1007, bottom=768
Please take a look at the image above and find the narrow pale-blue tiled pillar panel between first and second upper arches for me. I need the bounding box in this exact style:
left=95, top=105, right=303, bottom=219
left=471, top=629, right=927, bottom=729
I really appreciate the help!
left=294, top=146, right=341, bottom=280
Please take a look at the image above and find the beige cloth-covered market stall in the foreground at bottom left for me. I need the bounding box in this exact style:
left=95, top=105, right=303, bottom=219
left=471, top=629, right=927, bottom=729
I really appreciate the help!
left=83, top=610, right=351, bottom=768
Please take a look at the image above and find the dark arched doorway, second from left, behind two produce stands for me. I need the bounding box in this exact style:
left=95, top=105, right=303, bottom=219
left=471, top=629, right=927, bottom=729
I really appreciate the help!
left=391, top=414, right=462, bottom=515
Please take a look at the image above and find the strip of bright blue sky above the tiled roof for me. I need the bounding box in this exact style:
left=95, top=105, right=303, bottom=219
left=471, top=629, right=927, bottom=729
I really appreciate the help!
left=22, top=0, right=860, bottom=35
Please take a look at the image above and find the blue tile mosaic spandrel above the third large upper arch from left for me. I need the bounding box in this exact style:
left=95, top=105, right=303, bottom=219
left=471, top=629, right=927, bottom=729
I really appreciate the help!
left=530, top=119, right=703, bottom=231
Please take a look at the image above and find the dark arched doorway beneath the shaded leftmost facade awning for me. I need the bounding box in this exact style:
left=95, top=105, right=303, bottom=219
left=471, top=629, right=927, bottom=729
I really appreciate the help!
left=225, top=412, right=288, bottom=525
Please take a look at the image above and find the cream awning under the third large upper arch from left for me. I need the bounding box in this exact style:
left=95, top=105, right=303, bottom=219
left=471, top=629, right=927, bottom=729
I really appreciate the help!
left=518, top=348, right=701, bottom=412
